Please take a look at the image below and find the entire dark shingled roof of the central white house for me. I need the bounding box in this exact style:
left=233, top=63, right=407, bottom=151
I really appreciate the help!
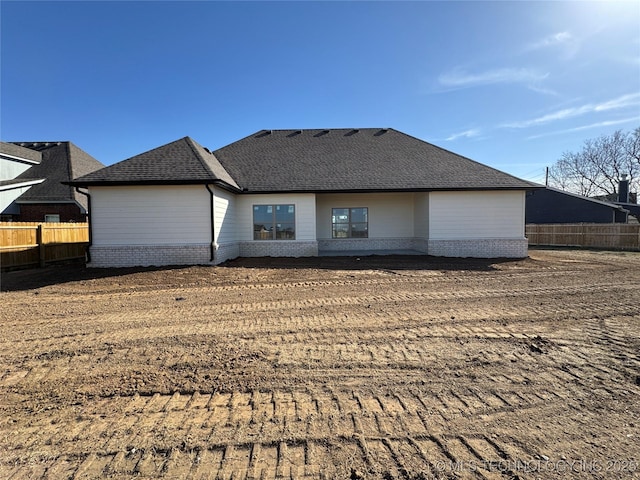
left=72, top=128, right=539, bottom=193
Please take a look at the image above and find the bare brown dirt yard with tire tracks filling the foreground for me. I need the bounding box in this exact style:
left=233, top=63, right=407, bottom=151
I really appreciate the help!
left=0, top=250, right=640, bottom=480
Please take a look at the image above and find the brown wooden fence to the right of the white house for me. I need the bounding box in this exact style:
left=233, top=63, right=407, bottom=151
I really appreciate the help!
left=525, top=223, right=640, bottom=250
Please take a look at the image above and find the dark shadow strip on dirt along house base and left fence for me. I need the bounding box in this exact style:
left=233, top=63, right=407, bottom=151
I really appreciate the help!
left=0, top=255, right=523, bottom=292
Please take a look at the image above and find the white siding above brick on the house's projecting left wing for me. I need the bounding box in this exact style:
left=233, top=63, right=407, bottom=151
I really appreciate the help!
left=89, top=185, right=211, bottom=245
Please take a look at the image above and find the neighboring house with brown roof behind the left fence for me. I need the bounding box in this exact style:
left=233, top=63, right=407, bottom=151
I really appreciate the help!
left=0, top=142, right=104, bottom=222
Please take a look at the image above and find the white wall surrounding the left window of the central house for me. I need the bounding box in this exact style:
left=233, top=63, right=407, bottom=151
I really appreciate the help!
left=236, top=193, right=316, bottom=242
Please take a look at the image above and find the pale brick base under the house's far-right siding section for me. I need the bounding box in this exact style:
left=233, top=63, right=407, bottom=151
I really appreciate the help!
left=427, top=238, right=528, bottom=258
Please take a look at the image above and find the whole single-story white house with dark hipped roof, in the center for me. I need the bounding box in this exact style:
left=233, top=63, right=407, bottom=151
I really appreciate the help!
left=70, top=128, right=539, bottom=267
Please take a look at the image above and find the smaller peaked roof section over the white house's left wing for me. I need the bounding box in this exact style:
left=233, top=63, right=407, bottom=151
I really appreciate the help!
left=71, top=137, right=238, bottom=189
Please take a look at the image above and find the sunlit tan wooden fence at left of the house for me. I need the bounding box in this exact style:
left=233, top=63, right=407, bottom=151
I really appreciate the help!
left=0, top=222, right=89, bottom=270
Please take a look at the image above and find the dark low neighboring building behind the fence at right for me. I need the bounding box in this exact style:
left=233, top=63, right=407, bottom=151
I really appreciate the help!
left=526, top=187, right=629, bottom=224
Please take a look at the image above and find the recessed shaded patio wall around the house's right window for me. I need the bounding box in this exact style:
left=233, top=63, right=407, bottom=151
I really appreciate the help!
left=316, top=193, right=414, bottom=240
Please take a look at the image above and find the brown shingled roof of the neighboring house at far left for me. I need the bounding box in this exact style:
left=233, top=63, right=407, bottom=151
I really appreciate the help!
left=12, top=142, right=104, bottom=209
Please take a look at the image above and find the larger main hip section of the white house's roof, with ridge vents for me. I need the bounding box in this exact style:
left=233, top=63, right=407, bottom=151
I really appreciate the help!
left=214, top=128, right=536, bottom=192
